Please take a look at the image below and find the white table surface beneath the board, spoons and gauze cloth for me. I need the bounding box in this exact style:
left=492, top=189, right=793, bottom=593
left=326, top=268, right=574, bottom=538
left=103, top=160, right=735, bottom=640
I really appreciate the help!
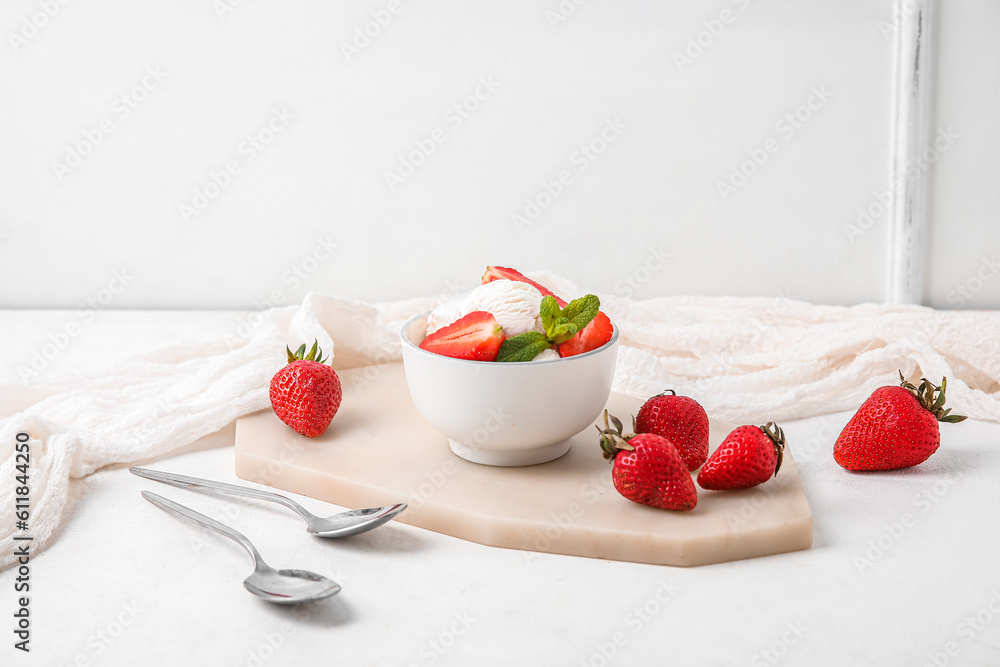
left=0, top=311, right=1000, bottom=667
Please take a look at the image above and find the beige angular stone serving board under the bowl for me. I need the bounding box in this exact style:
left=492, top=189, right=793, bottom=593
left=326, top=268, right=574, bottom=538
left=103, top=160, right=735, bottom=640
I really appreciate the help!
left=236, top=364, right=812, bottom=566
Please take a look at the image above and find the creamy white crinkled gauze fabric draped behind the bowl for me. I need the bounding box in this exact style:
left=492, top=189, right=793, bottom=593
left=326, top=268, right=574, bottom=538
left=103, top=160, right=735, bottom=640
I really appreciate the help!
left=0, top=273, right=1000, bottom=569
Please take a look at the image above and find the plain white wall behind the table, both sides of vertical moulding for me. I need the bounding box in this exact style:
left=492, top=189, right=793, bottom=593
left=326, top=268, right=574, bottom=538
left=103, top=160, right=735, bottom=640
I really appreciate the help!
left=0, top=0, right=1000, bottom=308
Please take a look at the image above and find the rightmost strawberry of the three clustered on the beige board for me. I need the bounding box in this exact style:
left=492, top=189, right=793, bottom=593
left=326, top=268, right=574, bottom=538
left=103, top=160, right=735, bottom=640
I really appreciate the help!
left=698, top=422, right=785, bottom=491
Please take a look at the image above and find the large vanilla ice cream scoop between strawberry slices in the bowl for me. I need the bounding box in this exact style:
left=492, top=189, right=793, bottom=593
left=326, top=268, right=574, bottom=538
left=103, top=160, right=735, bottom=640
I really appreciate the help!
left=427, top=280, right=545, bottom=338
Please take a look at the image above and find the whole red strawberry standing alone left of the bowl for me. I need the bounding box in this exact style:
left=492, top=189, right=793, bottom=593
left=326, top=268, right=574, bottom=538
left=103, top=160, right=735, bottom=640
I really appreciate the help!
left=270, top=342, right=343, bottom=438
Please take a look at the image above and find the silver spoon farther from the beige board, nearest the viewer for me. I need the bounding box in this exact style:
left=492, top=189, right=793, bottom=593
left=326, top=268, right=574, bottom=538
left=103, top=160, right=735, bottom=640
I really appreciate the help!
left=142, top=491, right=340, bottom=604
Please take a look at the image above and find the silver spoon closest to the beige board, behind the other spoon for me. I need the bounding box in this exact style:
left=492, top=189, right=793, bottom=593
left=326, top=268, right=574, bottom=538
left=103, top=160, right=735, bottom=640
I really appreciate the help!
left=129, top=467, right=406, bottom=537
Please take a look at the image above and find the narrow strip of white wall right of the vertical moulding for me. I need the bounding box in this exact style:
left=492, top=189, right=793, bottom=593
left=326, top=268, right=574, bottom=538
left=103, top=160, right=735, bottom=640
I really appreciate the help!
left=924, top=0, right=1000, bottom=308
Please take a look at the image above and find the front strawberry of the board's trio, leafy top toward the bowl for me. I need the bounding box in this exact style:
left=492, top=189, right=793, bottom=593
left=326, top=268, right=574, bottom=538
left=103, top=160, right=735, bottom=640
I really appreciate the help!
left=597, top=410, right=698, bottom=511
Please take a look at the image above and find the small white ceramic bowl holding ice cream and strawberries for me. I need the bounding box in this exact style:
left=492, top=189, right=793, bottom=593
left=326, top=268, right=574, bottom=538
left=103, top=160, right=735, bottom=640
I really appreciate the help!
left=400, top=313, right=618, bottom=466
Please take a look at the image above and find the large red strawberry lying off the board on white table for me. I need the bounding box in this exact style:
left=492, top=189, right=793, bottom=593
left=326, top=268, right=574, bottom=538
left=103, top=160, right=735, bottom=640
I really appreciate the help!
left=833, top=372, right=965, bottom=470
